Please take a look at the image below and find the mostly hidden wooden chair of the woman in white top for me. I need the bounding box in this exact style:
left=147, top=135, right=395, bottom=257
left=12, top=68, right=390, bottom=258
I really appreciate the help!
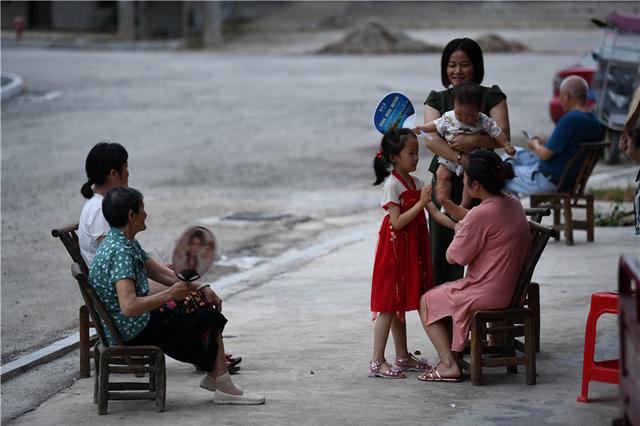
left=51, top=223, right=97, bottom=377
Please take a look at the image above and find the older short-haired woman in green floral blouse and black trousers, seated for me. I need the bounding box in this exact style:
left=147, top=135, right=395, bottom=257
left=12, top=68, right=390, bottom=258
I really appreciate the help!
left=89, top=187, right=264, bottom=405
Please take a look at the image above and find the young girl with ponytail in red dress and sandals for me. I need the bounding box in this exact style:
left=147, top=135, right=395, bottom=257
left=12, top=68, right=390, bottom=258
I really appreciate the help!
left=369, top=129, right=433, bottom=379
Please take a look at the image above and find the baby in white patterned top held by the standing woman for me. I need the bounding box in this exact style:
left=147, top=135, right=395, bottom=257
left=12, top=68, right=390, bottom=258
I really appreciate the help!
left=414, top=81, right=516, bottom=220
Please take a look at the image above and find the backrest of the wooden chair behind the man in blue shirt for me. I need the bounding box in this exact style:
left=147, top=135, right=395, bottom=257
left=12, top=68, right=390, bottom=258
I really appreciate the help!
left=558, top=142, right=609, bottom=195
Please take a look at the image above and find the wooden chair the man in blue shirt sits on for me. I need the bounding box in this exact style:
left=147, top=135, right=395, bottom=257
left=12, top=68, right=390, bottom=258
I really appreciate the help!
left=530, top=142, right=609, bottom=246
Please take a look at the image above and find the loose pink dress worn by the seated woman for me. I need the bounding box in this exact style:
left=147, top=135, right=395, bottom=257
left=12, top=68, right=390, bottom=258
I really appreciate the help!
left=424, top=194, right=531, bottom=352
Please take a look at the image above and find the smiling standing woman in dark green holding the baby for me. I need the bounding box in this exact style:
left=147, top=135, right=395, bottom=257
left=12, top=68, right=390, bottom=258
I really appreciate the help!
left=424, top=38, right=510, bottom=284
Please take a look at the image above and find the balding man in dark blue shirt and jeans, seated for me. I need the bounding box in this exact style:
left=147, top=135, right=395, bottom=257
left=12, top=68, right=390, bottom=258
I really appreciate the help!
left=505, top=75, right=604, bottom=195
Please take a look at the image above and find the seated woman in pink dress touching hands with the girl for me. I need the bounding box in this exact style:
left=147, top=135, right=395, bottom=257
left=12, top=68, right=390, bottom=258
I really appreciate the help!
left=418, top=150, right=530, bottom=381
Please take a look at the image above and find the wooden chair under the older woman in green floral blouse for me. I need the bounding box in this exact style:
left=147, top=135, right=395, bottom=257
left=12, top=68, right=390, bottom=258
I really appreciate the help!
left=71, top=263, right=166, bottom=414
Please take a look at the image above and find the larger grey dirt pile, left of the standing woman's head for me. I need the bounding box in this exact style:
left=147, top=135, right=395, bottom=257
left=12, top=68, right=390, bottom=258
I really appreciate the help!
left=316, top=18, right=442, bottom=55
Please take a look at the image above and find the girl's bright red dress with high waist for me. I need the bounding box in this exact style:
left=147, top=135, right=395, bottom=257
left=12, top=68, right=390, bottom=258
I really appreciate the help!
left=371, top=171, right=433, bottom=320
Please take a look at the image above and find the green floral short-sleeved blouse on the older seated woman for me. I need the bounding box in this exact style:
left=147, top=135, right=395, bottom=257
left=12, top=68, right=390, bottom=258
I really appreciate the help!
left=89, top=228, right=150, bottom=345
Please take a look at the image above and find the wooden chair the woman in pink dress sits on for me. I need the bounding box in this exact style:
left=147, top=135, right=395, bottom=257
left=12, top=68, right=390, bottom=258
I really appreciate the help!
left=462, top=221, right=553, bottom=385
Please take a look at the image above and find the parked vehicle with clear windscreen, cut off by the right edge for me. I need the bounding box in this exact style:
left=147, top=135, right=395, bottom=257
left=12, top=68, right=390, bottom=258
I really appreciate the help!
left=592, top=12, right=640, bottom=164
